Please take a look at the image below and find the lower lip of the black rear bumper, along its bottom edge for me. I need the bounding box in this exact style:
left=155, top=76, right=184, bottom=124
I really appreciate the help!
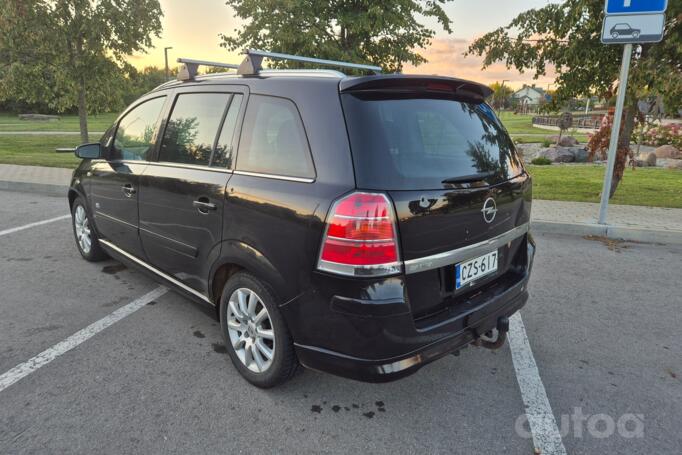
left=295, top=279, right=528, bottom=382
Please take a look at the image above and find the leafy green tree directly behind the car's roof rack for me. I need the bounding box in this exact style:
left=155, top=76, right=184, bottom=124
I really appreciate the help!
left=220, top=0, right=452, bottom=71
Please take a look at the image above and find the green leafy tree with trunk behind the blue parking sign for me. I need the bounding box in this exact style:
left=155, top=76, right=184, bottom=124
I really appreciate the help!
left=465, top=0, right=682, bottom=196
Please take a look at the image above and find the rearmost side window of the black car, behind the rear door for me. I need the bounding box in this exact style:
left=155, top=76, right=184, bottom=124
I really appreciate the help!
left=237, top=95, right=315, bottom=178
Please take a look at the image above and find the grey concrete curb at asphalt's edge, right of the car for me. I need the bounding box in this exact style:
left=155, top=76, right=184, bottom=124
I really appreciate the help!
left=531, top=220, right=682, bottom=245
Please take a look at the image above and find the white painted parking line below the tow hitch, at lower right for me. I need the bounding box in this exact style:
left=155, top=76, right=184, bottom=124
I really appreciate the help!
left=508, top=312, right=566, bottom=455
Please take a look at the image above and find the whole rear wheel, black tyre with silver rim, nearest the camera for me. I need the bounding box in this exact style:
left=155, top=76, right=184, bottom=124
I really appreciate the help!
left=220, top=272, right=298, bottom=389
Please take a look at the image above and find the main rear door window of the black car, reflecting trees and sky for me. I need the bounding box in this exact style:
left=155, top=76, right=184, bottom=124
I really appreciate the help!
left=159, top=93, right=230, bottom=166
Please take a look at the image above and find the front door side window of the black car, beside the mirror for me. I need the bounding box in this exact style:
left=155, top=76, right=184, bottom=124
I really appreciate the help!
left=110, top=97, right=166, bottom=160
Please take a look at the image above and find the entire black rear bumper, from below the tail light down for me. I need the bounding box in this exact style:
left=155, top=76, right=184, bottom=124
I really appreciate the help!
left=283, top=235, right=535, bottom=382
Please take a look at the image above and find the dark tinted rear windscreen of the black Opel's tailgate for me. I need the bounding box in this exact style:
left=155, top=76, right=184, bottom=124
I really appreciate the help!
left=341, top=92, right=523, bottom=190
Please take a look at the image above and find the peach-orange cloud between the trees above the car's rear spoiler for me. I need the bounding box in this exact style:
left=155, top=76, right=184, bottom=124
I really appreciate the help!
left=405, top=38, right=554, bottom=87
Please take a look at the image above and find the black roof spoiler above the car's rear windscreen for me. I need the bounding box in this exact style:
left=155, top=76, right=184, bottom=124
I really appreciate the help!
left=339, top=74, right=493, bottom=103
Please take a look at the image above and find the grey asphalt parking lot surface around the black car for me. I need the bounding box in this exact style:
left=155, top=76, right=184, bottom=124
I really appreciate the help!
left=0, top=191, right=682, bottom=454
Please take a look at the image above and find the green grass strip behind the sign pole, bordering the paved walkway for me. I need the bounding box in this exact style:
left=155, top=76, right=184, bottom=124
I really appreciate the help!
left=528, top=165, right=682, bottom=208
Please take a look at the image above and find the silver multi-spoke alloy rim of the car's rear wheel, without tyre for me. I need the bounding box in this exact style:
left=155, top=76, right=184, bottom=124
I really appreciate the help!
left=227, top=288, right=275, bottom=373
